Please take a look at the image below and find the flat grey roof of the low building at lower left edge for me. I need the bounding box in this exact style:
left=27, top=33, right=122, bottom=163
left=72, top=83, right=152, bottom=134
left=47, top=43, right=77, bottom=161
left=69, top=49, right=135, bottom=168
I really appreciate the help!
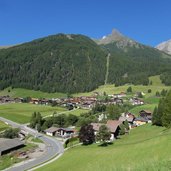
left=0, top=138, right=24, bottom=152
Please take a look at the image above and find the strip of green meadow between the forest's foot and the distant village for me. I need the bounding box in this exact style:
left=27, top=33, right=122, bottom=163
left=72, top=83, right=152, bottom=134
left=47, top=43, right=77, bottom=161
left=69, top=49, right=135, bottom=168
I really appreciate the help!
left=0, top=75, right=171, bottom=98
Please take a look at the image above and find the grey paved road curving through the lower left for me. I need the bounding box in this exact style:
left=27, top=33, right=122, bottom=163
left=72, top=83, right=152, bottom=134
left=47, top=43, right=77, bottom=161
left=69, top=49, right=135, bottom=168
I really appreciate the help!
left=0, top=117, right=64, bottom=171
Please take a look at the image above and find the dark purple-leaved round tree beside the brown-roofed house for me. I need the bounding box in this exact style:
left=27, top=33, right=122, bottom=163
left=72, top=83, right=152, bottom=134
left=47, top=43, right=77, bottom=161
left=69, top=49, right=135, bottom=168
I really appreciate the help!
left=79, top=125, right=95, bottom=145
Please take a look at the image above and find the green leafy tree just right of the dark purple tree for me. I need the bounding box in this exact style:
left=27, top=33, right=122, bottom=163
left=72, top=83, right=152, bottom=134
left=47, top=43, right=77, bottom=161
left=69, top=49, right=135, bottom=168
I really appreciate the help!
left=96, top=125, right=111, bottom=144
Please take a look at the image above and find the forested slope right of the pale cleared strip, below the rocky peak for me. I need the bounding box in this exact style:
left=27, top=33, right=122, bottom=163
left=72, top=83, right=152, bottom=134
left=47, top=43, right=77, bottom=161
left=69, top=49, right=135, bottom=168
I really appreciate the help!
left=101, top=40, right=171, bottom=86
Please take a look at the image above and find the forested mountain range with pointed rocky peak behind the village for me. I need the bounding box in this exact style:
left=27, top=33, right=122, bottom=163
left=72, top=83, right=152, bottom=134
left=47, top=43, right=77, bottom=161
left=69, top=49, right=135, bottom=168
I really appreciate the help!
left=0, top=30, right=171, bottom=93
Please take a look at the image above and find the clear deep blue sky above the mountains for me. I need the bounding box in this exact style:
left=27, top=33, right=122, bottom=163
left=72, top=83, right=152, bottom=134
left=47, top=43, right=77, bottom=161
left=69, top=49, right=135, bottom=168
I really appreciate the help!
left=0, top=0, right=171, bottom=46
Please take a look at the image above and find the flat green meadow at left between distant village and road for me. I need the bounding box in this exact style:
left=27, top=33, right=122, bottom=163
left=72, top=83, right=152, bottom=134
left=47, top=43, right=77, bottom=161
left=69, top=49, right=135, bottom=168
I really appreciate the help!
left=0, top=103, right=66, bottom=123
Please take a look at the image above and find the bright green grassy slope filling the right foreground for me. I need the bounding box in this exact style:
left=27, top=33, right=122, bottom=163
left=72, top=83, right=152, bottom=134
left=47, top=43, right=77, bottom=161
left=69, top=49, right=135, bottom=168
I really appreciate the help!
left=37, top=124, right=171, bottom=171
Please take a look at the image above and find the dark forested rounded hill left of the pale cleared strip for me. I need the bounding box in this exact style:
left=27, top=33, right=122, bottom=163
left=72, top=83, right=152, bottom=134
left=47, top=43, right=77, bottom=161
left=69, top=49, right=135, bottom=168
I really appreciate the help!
left=0, top=34, right=107, bottom=93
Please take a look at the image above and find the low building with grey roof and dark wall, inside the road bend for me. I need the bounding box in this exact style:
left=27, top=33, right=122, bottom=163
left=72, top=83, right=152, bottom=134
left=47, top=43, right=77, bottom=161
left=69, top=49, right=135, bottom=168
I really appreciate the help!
left=0, top=138, right=24, bottom=156
